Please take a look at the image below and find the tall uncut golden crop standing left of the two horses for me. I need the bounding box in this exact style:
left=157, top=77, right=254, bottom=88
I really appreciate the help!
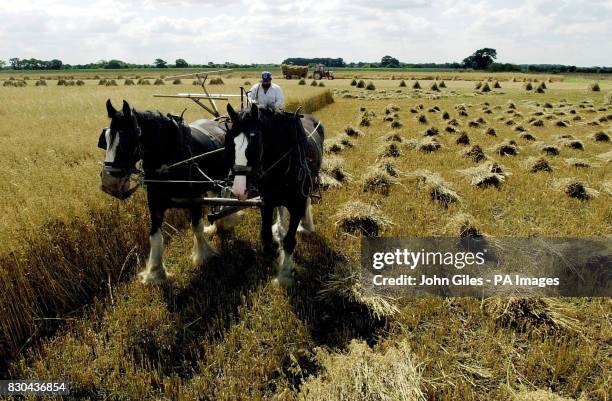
left=0, top=82, right=333, bottom=372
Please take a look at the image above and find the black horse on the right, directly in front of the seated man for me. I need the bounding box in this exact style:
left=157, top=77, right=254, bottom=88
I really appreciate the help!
left=225, top=105, right=324, bottom=285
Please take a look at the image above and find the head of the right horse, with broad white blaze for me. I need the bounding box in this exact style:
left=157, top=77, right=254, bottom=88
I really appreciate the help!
left=225, top=104, right=262, bottom=199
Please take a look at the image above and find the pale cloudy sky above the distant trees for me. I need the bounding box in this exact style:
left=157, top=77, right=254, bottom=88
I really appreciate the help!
left=0, top=0, right=612, bottom=66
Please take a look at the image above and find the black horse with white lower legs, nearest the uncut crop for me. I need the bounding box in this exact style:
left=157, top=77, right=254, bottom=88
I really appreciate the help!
left=98, top=99, right=232, bottom=283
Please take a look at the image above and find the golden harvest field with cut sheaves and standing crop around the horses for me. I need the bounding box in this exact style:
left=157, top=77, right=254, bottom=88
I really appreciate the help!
left=0, top=70, right=612, bottom=401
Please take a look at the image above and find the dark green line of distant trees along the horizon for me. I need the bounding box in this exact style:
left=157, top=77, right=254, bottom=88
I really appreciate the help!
left=0, top=47, right=612, bottom=74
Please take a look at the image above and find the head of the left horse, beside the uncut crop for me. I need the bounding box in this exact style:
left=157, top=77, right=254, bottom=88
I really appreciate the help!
left=98, top=99, right=141, bottom=199
